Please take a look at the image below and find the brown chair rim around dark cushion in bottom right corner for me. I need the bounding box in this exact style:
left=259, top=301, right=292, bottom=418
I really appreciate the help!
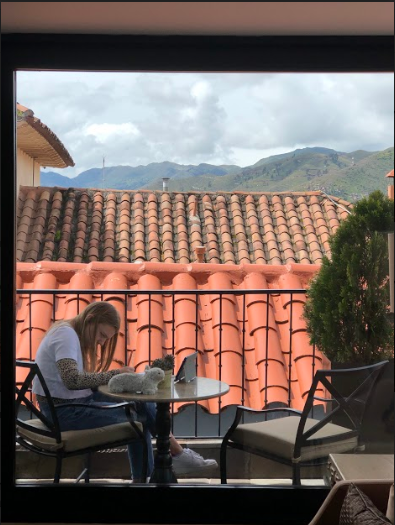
left=309, top=479, right=393, bottom=525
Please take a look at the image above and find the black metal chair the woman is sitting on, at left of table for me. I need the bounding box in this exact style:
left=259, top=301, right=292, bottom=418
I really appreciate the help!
left=16, top=360, right=148, bottom=483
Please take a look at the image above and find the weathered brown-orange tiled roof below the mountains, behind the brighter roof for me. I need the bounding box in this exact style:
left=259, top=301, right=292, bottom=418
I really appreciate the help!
left=16, top=186, right=352, bottom=265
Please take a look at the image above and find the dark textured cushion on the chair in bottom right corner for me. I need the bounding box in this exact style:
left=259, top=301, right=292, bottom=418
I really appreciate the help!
left=339, top=483, right=391, bottom=525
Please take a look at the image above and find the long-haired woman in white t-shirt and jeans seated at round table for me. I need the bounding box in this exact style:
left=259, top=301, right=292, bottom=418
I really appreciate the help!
left=33, top=301, right=218, bottom=483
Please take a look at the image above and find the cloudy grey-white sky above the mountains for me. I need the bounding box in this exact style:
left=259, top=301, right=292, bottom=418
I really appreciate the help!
left=17, top=71, right=394, bottom=177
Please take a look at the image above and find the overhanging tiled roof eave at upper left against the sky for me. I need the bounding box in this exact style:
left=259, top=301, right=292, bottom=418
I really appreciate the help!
left=16, top=104, right=74, bottom=168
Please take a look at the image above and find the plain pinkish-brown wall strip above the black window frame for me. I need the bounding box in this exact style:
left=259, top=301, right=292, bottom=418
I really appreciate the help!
left=1, top=2, right=394, bottom=36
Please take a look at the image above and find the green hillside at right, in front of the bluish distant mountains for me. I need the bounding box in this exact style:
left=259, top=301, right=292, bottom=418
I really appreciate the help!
left=147, top=148, right=394, bottom=202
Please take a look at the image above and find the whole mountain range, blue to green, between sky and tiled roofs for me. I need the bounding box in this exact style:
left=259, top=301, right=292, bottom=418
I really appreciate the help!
left=40, top=147, right=394, bottom=202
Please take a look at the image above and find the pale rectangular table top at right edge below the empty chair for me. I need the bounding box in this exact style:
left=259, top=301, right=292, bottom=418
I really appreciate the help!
left=329, top=454, right=394, bottom=481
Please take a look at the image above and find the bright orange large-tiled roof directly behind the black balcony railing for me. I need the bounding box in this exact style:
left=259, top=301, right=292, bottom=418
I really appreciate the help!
left=16, top=260, right=329, bottom=413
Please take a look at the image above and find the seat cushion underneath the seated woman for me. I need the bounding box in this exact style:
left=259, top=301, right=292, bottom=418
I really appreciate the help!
left=17, top=419, right=142, bottom=452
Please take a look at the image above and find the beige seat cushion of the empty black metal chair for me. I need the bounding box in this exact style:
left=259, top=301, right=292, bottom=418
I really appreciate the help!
left=231, top=416, right=358, bottom=461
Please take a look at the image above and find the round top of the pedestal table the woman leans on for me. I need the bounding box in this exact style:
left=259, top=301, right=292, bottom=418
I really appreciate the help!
left=99, top=377, right=229, bottom=403
